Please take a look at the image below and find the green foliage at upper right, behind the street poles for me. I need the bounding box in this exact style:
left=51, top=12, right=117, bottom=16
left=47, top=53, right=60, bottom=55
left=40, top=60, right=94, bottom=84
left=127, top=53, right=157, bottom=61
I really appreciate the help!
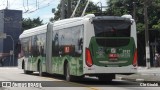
left=106, top=0, right=160, bottom=32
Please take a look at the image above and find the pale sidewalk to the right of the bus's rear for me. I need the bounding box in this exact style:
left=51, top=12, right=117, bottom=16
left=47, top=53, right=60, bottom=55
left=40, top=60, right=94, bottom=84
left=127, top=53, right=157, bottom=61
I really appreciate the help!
left=118, top=67, right=160, bottom=81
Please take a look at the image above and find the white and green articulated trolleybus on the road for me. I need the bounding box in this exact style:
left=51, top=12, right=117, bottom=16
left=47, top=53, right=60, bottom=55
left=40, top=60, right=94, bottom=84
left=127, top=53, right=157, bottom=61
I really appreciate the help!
left=19, top=14, right=137, bottom=81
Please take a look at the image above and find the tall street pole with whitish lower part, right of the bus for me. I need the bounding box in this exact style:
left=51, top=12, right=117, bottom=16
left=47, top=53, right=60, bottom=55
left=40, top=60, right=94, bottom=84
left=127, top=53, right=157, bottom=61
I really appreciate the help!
left=144, top=0, right=151, bottom=69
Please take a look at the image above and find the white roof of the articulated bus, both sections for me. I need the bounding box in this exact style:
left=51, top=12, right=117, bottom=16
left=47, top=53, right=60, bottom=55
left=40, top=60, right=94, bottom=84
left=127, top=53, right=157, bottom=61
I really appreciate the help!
left=19, top=14, right=133, bottom=38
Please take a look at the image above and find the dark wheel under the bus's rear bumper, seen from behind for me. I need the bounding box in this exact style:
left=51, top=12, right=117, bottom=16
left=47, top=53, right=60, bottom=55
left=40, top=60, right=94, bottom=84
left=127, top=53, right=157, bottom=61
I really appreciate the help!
left=98, top=74, right=115, bottom=82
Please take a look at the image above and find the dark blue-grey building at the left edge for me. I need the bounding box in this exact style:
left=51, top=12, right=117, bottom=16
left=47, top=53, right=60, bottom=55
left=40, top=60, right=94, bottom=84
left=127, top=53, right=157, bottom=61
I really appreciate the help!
left=0, top=9, right=22, bottom=66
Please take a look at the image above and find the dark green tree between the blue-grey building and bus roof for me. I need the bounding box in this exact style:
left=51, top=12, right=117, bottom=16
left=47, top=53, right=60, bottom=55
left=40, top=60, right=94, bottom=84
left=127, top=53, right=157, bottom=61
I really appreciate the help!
left=22, top=17, right=43, bottom=30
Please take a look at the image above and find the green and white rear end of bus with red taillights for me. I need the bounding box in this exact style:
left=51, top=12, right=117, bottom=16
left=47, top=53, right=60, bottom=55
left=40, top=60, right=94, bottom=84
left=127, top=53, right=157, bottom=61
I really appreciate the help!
left=84, top=16, right=137, bottom=80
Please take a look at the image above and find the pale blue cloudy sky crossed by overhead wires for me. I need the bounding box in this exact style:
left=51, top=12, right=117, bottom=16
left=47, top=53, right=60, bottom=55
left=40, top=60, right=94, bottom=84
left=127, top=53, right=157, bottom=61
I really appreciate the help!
left=0, top=0, right=106, bottom=23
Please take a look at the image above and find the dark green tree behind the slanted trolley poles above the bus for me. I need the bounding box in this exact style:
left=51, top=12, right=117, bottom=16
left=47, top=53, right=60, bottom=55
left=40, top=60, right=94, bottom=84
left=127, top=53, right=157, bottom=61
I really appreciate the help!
left=51, top=0, right=100, bottom=20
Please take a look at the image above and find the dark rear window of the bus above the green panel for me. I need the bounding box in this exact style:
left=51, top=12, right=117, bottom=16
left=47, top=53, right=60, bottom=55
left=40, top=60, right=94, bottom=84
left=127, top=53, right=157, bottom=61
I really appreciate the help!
left=93, top=20, right=131, bottom=37
